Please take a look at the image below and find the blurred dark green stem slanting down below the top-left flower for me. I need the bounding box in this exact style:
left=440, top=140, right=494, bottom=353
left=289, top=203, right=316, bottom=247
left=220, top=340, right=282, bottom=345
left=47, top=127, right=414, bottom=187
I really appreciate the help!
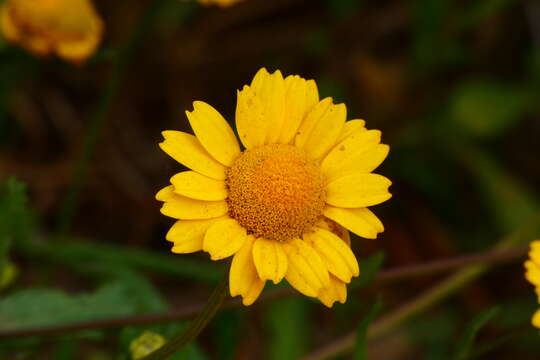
left=57, top=0, right=163, bottom=234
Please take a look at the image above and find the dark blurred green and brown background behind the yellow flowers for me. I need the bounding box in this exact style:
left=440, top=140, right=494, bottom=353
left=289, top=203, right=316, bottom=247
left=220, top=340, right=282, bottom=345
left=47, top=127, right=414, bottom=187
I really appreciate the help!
left=0, top=0, right=540, bottom=360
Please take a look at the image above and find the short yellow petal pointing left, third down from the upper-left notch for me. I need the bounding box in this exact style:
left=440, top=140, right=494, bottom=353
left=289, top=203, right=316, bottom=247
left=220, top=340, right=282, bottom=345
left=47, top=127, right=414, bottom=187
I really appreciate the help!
left=171, top=171, right=227, bottom=201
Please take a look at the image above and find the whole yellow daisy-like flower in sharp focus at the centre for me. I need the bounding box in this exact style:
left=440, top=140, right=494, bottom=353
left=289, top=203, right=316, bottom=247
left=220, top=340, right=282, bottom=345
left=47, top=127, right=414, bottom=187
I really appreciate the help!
left=156, top=69, right=391, bottom=307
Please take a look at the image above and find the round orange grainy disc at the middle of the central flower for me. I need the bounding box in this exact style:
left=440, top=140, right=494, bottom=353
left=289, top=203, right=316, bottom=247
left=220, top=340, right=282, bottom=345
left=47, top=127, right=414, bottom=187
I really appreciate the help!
left=226, top=144, right=326, bottom=241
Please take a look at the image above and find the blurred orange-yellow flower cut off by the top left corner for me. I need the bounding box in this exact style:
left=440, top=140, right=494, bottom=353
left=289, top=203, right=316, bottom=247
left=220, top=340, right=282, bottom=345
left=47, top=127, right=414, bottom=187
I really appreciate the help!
left=0, top=0, right=103, bottom=63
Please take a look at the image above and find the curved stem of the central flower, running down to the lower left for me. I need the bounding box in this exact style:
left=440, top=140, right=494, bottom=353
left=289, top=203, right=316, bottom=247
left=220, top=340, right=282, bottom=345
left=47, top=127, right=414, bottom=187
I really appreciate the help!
left=140, top=275, right=229, bottom=360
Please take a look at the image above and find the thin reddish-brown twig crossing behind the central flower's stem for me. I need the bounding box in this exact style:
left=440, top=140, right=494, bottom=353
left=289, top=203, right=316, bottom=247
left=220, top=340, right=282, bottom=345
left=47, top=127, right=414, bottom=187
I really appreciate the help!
left=0, top=247, right=527, bottom=339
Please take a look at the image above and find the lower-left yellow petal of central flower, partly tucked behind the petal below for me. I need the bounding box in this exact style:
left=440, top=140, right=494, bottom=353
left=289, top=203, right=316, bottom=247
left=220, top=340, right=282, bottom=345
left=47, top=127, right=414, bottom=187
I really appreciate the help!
left=165, top=217, right=224, bottom=254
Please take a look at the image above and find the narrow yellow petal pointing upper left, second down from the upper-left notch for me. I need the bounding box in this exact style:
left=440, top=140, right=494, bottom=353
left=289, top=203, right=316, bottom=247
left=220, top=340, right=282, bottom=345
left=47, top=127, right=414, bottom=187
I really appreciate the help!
left=159, top=131, right=225, bottom=180
